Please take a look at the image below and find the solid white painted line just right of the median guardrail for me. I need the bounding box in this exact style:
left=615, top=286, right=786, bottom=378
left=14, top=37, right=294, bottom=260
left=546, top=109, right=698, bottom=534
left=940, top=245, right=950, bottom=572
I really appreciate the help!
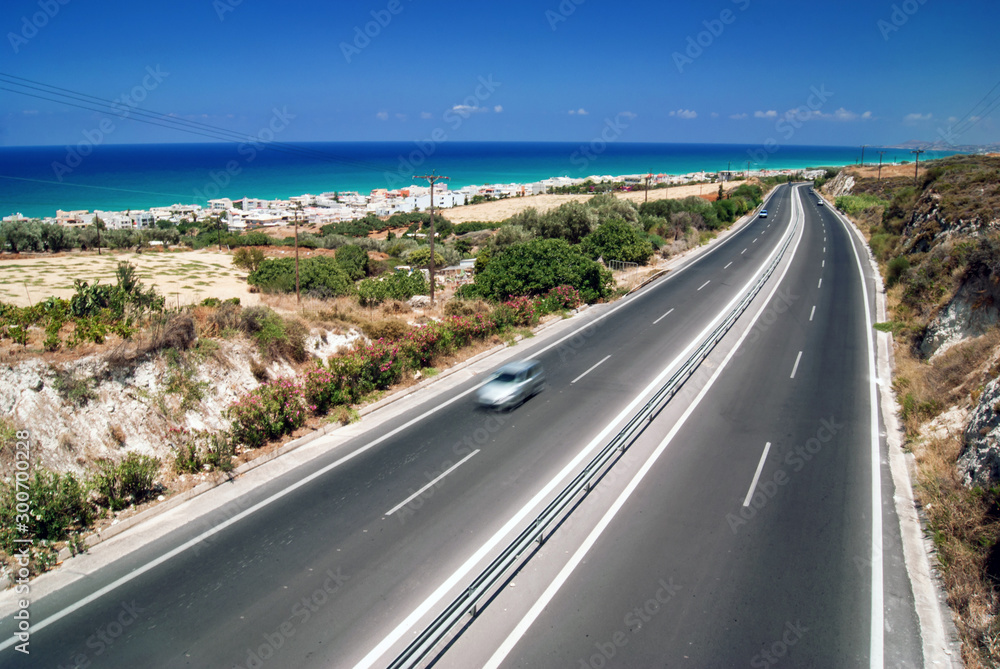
left=483, top=191, right=802, bottom=669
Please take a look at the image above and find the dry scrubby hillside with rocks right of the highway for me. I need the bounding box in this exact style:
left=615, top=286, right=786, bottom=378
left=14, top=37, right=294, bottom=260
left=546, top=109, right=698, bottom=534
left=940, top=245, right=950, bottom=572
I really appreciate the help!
left=827, top=156, right=1000, bottom=667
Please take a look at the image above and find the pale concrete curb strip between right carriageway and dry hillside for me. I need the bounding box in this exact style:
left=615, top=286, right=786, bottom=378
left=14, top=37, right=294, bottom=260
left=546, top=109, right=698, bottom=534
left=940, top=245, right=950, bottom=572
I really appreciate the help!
left=817, top=192, right=964, bottom=668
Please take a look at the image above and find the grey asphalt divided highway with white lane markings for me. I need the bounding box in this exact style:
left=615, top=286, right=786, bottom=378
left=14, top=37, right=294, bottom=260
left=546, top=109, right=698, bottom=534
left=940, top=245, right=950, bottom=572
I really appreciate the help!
left=0, top=186, right=920, bottom=667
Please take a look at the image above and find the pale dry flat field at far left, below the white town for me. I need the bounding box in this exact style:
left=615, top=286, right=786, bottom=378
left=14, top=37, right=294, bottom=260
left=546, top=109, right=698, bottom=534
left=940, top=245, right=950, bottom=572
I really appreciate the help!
left=0, top=250, right=259, bottom=307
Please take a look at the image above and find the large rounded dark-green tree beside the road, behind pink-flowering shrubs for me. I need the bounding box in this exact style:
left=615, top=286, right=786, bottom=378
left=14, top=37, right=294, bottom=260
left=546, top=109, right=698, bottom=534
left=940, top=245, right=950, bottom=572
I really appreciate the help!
left=475, top=239, right=613, bottom=302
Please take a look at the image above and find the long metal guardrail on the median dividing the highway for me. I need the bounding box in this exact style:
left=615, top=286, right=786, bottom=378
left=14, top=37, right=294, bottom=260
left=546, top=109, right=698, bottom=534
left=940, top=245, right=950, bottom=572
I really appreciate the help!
left=389, top=201, right=794, bottom=669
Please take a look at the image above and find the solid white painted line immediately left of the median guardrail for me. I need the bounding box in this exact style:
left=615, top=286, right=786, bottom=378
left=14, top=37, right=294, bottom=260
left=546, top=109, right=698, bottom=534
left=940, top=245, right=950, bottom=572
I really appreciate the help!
left=356, top=188, right=802, bottom=669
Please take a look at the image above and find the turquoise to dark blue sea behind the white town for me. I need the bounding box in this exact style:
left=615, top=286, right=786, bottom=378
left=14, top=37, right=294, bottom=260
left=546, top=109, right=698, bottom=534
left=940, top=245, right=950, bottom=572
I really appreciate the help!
left=0, top=141, right=950, bottom=218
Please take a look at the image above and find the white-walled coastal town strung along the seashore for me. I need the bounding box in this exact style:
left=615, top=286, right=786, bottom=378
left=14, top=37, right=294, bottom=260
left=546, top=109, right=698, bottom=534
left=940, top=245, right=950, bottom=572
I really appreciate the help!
left=2, top=169, right=823, bottom=232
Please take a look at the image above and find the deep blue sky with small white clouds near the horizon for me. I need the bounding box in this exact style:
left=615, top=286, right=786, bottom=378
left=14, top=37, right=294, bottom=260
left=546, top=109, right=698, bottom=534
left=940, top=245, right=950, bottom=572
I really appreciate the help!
left=0, top=0, right=1000, bottom=145
